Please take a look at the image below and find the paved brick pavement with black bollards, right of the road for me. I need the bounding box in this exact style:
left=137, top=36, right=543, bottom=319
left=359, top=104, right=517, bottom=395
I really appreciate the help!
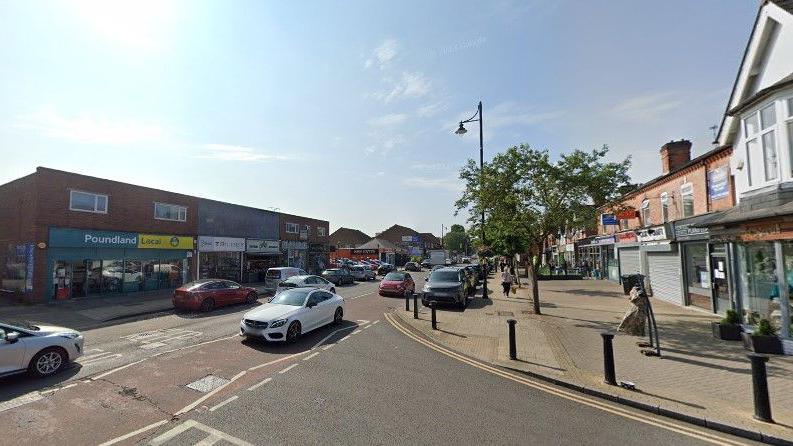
left=396, top=278, right=793, bottom=441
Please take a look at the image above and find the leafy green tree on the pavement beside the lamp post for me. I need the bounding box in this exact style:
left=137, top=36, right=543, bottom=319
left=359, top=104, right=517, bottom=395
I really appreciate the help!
left=455, top=144, right=631, bottom=314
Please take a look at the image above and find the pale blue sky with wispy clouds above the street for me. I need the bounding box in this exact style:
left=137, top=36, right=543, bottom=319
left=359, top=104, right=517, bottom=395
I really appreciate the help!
left=0, top=0, right=758, bottom=235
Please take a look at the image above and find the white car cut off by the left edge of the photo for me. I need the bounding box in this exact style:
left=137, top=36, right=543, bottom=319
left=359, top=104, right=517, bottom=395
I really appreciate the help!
left=0, top=319, right=84, bottom=377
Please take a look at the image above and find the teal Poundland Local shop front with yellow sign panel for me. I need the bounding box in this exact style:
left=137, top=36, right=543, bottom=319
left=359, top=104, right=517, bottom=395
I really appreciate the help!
left=47, top=228, right=193, bottom=300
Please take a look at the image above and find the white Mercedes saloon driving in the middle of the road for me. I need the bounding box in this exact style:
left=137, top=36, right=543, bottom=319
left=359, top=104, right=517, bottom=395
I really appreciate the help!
left=240, top=287, right=344, bottom=342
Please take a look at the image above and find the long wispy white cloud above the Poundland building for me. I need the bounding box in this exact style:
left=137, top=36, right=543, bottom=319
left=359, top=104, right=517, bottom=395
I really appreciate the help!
left=13, top=106, right=166, bottom=144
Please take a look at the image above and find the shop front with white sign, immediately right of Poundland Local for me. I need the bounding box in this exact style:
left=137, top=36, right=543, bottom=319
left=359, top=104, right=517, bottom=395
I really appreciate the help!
left=198, top=235, right=245, bottom=282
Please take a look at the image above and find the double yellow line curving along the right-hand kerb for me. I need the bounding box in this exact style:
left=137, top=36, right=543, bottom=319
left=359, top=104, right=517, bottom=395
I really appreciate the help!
left=385, top=313, right=747, bottom=446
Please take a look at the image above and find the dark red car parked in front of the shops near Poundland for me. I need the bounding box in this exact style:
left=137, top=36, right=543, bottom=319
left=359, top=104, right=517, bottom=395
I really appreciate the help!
left=173, top=279, right=259, bottom=311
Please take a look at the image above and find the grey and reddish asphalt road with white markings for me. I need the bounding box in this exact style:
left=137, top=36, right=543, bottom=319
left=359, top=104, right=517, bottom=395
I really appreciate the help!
left=0, top=275, right=747, bottom=445
